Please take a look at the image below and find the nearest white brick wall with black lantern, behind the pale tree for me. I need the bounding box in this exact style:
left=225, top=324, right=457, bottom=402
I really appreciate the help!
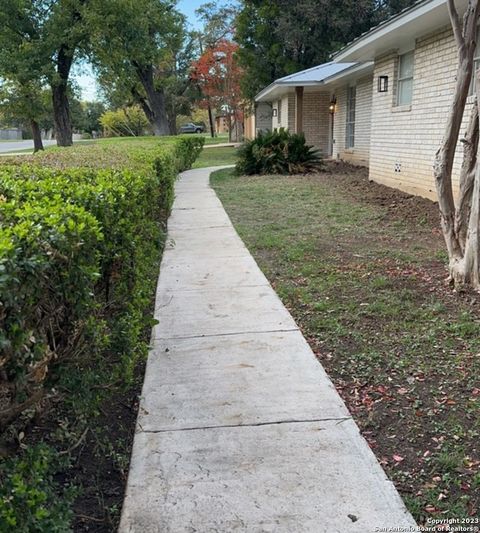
left=370, top=28, right=471, bottom=199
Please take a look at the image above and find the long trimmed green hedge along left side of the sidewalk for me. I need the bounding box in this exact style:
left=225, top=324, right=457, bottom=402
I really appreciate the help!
left=0, top=137, right=203, bottom=430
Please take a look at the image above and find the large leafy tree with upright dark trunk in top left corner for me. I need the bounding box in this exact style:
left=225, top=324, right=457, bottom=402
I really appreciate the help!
left=0, top=0, right=89, bottom=146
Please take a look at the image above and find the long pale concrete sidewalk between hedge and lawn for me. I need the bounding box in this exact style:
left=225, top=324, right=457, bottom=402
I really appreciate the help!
left=120, top=169, right=415, bottom=533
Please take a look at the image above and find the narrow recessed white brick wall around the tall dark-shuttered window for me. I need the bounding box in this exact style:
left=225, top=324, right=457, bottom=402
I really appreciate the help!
left=333, top=75, right=373, bottom=166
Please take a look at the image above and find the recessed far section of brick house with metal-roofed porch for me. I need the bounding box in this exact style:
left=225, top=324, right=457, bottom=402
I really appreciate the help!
left=255, top=62, right=373, bottom=165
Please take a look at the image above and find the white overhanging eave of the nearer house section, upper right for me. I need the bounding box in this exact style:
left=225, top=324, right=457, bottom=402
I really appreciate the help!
left=333, top=0, right=467, bottom=61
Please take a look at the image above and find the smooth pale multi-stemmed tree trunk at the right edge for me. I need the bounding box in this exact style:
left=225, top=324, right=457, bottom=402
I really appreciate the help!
left=434, top=0, right=480, bottom=290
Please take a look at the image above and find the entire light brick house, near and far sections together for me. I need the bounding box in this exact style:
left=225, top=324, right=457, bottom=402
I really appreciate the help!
left=256, top=0, right=470, bottom=199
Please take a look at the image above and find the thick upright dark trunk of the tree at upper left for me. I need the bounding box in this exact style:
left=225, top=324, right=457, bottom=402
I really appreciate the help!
left=52, top=46, right=73, bottom=146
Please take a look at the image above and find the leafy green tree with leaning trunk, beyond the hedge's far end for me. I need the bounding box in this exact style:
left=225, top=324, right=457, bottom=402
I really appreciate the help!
left=89, top=0, right=185, bottom=135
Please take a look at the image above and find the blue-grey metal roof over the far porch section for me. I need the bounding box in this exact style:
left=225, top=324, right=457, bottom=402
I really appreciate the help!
left=255, top=61, right=373, bottom=102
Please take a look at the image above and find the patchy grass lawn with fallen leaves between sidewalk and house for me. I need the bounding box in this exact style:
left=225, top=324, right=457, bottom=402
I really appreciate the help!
left=212, top=164, right=480, bottom=523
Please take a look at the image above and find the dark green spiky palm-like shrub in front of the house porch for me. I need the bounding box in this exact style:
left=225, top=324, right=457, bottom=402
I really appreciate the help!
left=236, top=128, right=322, bottom=175
